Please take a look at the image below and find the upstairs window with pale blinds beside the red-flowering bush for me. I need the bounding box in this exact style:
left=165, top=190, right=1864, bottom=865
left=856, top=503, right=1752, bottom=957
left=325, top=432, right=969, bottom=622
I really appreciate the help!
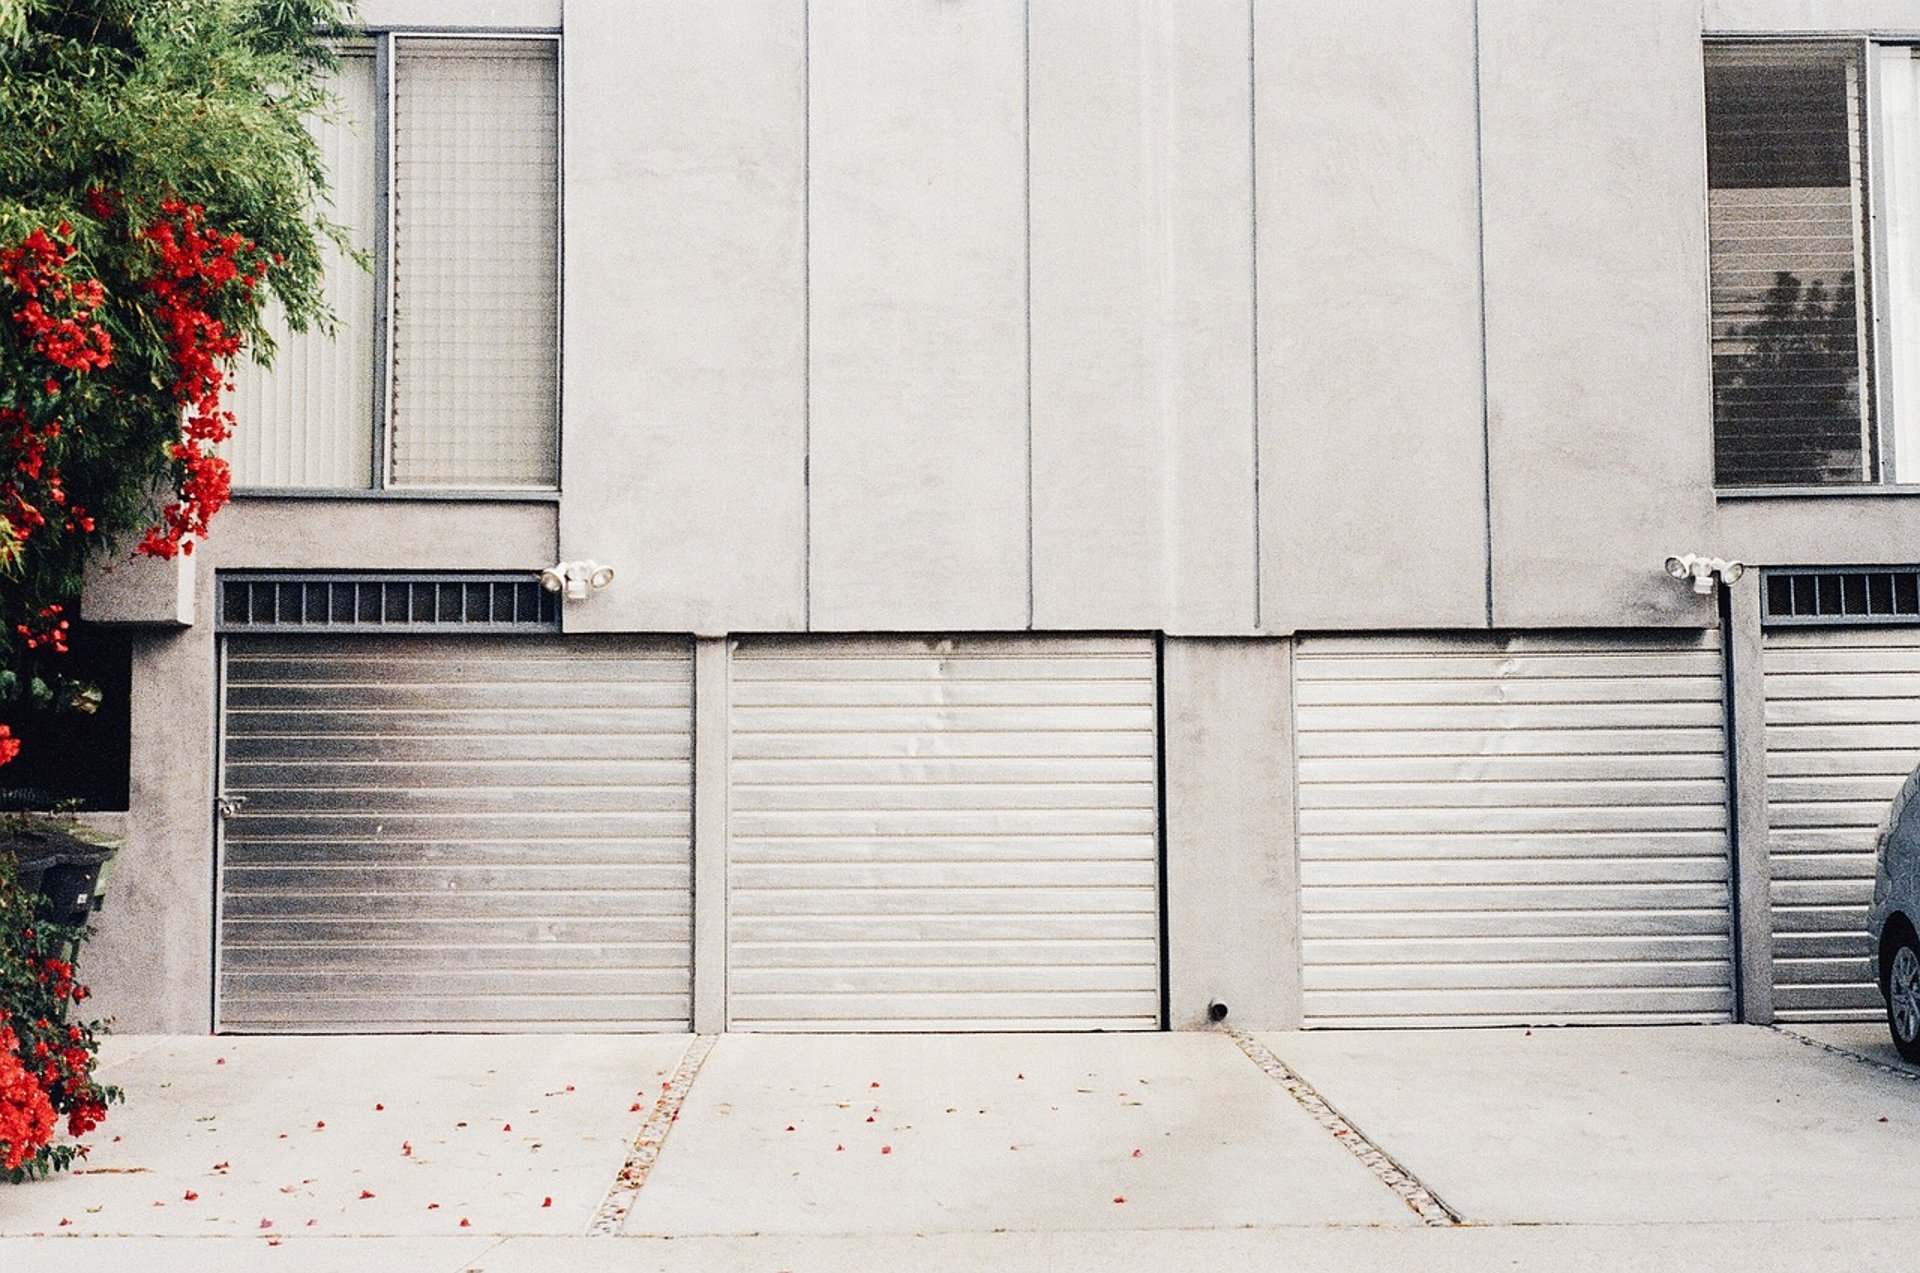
left=225, top=35, right=559, bottom=490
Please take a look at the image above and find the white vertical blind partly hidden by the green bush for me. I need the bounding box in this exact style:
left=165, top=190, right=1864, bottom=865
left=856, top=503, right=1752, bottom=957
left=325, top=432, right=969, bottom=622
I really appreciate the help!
left=223, top=54, right=380, bottom=488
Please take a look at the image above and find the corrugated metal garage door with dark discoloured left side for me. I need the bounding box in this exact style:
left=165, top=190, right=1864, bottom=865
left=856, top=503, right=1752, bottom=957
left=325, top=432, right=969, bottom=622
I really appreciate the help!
left=219, top=637, right=693, bottom=1031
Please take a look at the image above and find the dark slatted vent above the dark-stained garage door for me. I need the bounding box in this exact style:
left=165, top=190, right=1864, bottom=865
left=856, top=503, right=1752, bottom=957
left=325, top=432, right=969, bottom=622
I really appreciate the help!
left=219, top=574, right=561, bottom=632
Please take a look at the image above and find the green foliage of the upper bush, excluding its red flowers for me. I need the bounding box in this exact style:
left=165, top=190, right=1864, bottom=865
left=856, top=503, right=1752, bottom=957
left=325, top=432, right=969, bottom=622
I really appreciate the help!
left=0, top=0, right=357, bottom=752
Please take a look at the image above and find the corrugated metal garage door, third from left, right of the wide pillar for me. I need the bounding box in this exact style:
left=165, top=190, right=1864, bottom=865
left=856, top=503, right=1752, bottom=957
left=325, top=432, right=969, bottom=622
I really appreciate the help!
left=1296, top=634, right=1732, bottom=1025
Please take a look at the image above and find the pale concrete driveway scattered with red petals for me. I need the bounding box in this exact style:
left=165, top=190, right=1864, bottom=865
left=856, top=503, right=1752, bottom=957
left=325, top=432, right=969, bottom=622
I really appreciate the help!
left=0, top=1025, right=1920, bottom=1273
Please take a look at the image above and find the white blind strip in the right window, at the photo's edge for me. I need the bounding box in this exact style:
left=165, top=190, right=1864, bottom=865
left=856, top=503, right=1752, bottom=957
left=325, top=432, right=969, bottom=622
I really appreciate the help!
left=1876, top=46, right=1920, bottom=482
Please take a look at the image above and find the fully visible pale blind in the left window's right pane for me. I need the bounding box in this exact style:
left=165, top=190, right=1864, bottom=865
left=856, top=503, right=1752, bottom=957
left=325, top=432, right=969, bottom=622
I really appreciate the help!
left=390, top=38, right=559, bottom=486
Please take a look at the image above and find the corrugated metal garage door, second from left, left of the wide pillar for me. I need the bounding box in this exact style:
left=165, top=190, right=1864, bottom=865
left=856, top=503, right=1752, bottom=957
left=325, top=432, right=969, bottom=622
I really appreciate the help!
left=728, top=637, right=1160, bottom=1029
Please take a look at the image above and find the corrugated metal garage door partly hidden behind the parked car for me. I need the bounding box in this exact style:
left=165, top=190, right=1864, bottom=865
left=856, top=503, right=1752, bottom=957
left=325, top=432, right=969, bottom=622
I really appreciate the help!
left=1763, top=628, right=1920, bottom=1021
